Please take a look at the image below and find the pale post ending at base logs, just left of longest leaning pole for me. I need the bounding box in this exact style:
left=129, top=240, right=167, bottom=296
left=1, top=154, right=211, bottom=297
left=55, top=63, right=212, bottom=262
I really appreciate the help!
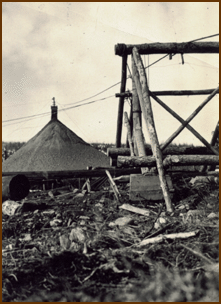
left=131, top=56, right=149, bottom=174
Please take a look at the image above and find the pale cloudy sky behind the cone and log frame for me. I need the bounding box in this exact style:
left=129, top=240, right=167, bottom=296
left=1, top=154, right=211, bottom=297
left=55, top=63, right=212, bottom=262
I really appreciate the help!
left=2, top=2, right=219, bottom=145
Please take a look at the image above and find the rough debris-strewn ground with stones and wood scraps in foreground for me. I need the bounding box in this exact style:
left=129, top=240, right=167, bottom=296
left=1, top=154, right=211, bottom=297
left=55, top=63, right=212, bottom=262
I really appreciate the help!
left=2, top=176, right=219, bottom=302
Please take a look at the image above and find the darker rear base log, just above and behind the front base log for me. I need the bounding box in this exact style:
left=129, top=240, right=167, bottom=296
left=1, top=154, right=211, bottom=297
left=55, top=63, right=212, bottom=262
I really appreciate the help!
left=107, top=146, right=218, bottom=158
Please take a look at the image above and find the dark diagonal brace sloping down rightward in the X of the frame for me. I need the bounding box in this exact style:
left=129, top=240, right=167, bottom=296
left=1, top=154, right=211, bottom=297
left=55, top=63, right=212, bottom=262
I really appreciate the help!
left=149, top=91, right=219, bottom=155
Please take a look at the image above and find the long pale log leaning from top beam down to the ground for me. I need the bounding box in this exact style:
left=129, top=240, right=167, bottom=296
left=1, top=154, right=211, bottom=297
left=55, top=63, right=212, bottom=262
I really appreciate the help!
left=133, top=47, right=173, bottom=212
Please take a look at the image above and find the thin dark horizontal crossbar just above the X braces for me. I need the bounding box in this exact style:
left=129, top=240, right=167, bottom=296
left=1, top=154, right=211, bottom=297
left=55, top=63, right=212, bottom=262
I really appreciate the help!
left=115, top=89, right=219, bottom=98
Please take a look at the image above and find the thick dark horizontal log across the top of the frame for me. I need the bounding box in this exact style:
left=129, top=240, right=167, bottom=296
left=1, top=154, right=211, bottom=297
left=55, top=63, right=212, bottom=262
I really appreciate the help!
left=115, top=41, right=219, bottom=56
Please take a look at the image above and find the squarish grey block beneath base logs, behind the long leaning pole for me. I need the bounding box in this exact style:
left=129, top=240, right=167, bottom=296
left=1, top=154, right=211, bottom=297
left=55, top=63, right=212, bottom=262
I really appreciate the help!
left=129, top=174, right=174, bottom=201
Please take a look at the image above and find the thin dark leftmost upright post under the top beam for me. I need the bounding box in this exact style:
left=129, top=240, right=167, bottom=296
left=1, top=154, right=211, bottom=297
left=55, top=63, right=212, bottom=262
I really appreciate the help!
left=116, top=55, right=127, bottom=148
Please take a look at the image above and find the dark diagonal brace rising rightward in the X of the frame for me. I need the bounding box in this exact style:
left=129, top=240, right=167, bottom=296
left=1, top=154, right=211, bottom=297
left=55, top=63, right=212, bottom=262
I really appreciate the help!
left=161, top=87, right=219, bottom=154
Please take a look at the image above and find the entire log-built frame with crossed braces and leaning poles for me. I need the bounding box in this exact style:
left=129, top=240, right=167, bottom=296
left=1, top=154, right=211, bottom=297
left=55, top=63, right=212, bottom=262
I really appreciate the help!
left=115, top=42, right=219, bottom=212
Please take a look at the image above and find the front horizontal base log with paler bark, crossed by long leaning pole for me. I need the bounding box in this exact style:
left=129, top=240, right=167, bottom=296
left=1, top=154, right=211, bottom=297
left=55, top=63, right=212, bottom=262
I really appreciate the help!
left=117, top=155, right=219, bottom=167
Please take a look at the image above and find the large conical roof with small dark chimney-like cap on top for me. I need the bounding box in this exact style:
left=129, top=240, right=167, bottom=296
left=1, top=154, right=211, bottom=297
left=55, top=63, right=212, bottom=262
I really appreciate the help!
left=2, top=104, right=110, bottom=172
